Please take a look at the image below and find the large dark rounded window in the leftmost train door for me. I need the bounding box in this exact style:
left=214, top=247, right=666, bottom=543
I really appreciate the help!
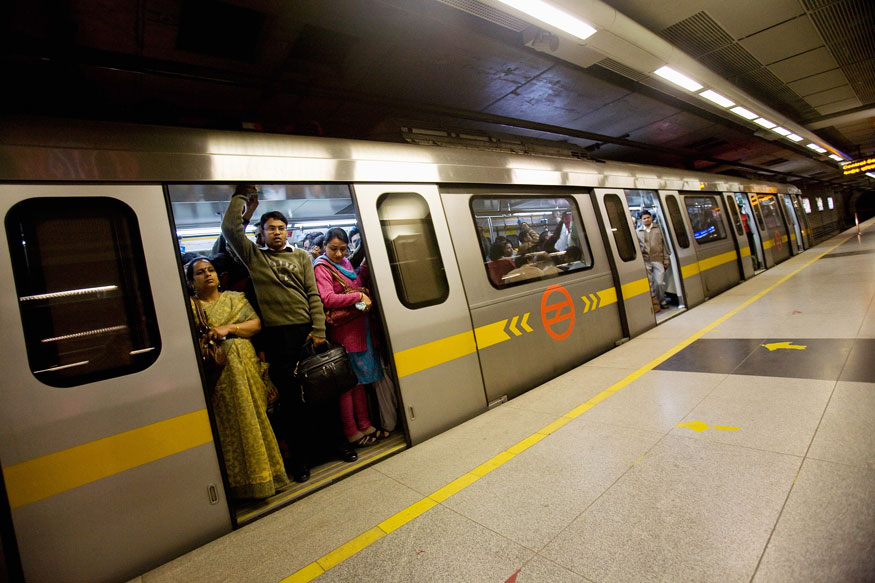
left=5, top=197, right=161, bottom=387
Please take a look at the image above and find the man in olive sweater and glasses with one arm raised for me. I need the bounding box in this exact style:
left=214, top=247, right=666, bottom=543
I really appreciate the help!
left=222, top=185, right=325, bottom=482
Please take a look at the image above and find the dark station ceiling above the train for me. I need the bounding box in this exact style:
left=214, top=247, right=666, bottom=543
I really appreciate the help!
left=0, top=0, right=875, bottom=190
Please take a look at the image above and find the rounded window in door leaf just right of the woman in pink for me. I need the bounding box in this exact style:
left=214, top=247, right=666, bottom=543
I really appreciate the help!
left=377, top=192, right=450, bottom=309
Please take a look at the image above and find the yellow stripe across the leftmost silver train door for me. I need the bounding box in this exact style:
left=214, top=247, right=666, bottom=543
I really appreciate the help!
left=3, top=409, right=213, bottom=509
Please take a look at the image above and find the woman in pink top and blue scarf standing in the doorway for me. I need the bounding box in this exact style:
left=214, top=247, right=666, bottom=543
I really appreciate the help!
left=313, top=227, right=389, bottom=447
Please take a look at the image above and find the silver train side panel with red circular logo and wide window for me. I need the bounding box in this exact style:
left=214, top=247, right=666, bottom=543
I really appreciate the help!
left=441, top=187, right=624, bottom=404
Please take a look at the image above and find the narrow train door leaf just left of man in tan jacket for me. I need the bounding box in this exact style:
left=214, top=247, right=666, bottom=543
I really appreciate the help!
left=593, top=189, right=656, bottom=337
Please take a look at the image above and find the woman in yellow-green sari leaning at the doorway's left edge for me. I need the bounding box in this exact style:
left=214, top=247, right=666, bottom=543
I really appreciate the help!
left=185, top=257, right=289, bottom=498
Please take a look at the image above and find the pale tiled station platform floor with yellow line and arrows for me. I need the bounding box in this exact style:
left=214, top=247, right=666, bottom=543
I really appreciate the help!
left=135, top=221, right=875, bottom=583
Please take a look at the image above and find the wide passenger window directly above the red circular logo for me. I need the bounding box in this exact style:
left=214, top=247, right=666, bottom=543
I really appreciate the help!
left=471, top=195, right=592, bottom=289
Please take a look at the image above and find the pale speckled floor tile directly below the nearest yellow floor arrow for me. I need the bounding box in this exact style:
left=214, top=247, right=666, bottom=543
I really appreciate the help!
left=539, top=435, right=802, bottom=583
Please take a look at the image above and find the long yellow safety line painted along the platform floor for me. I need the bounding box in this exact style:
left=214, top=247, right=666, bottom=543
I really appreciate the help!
left=280, top=227, right=853, bottom=583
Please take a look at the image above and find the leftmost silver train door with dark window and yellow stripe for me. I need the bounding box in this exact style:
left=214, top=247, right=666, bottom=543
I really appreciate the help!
left=0, top=185, right=231, bottom=581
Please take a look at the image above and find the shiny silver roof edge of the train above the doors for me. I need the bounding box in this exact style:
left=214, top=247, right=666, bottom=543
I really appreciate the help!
left=0, top=117, right=799, bottom=193
